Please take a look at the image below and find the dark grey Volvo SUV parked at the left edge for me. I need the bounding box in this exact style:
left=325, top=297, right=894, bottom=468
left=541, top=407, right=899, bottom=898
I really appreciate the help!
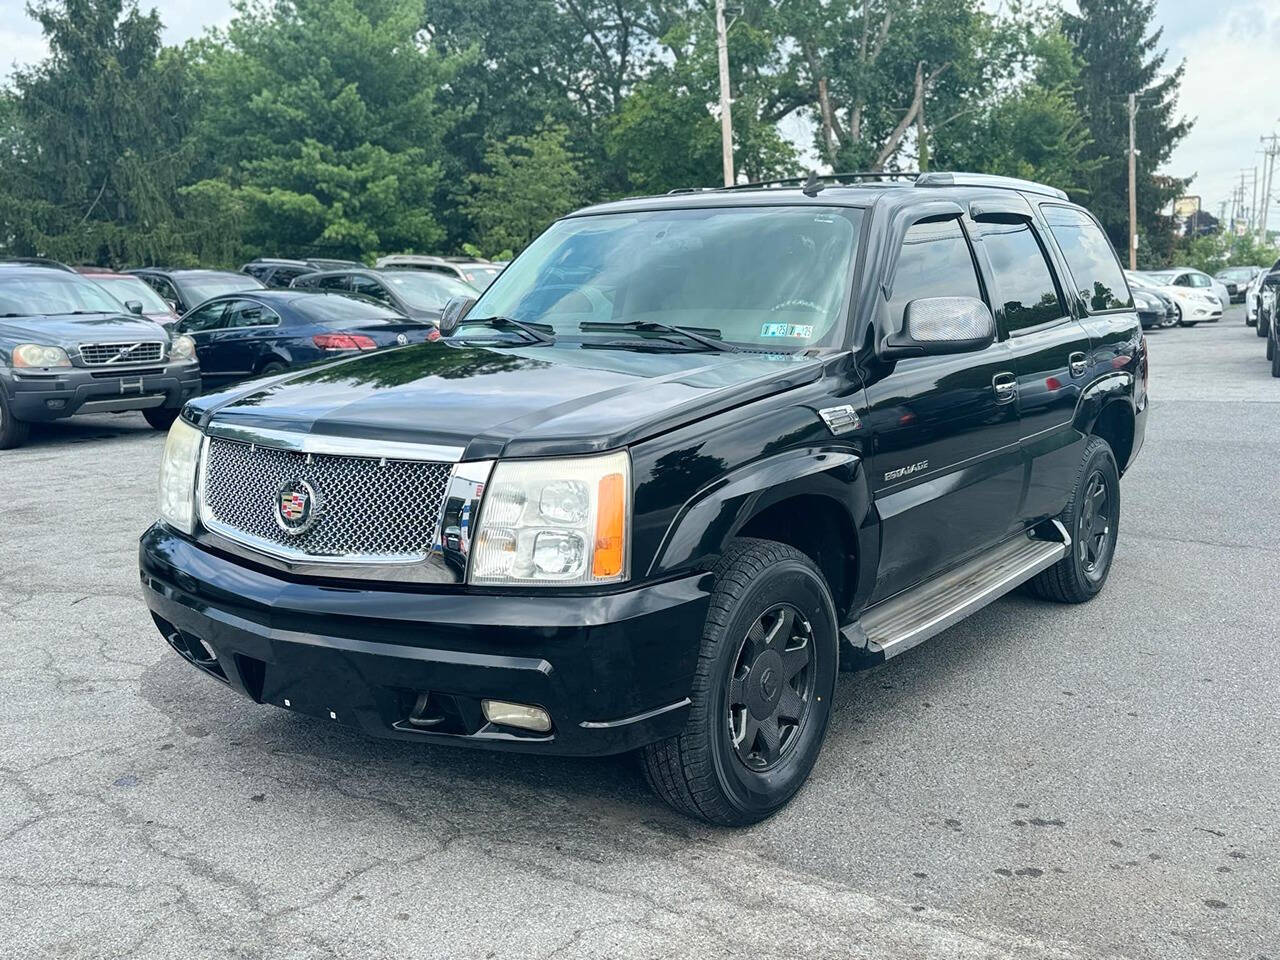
left=0, top=266, right=200, bottom=449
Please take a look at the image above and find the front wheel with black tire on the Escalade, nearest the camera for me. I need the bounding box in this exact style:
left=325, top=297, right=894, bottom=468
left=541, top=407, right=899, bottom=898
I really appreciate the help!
left=641, top=539, right=838, bottom=827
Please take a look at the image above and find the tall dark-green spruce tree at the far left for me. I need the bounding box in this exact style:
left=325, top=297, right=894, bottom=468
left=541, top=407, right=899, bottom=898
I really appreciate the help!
left=0, top=0, right=199, bottom=264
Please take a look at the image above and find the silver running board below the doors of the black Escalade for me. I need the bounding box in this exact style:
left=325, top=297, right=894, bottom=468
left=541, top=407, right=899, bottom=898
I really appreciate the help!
left=842, top=521, right=1071, bottom=660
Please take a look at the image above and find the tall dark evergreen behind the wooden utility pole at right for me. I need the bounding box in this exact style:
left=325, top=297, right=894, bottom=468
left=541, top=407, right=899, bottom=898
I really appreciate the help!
left=1064, top=0, right=1192, bottom=264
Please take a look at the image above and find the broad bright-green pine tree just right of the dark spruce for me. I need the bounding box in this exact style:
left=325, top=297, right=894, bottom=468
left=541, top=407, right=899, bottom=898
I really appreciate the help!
left=187, top=0, right=452, bottom=257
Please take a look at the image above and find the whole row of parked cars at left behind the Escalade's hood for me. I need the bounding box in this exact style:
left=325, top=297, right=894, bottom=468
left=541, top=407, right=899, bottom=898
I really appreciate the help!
left=0, top=255, right=503, bottom=449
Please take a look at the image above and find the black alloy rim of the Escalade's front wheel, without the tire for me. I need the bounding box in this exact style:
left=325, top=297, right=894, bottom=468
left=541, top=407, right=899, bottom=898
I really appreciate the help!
left=728, top=604, right=817, bottom=772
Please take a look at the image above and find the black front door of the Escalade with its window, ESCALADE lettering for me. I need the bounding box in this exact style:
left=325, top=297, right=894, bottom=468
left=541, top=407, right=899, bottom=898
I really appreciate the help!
left=865, top=220, right=1025, bottom=602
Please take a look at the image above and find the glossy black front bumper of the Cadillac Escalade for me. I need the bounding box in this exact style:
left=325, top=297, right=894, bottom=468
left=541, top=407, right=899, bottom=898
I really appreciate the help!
left=140, top=524, right=710, bottom=755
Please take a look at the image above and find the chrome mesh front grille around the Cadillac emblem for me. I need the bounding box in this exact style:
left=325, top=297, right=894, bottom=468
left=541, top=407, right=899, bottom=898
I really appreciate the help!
left=201, top=436, right=452, bottom=563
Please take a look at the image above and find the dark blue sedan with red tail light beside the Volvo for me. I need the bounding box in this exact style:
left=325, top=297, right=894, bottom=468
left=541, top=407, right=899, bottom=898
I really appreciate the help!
left=175, top=289, right=439, bottom=389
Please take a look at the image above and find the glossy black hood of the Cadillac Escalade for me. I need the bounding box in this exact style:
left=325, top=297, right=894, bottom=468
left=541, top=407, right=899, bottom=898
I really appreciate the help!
left=192, top=342, right=822, bottom=460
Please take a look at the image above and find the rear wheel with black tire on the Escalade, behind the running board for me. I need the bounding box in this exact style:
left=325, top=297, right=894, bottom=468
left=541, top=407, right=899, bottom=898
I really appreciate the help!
left=1028, top=436, right=1120, bottom=603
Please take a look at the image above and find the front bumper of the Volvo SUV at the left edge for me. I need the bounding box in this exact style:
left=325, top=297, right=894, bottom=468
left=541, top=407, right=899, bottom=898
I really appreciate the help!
left=0, top=361, right=200, bottom=421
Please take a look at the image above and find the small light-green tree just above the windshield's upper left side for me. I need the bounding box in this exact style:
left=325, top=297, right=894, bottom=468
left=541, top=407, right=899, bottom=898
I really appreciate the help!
left=466, top=127, right=582, bottom=252
